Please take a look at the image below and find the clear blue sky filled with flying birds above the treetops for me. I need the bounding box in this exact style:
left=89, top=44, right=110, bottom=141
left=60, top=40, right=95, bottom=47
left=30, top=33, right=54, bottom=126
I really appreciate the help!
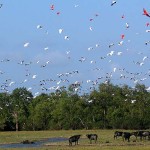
left=0, top=0, right=150, bottom=96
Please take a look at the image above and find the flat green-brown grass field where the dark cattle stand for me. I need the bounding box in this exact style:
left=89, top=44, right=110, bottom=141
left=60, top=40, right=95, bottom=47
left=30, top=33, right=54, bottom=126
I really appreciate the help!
left=0, top=130, right=150, bottom=150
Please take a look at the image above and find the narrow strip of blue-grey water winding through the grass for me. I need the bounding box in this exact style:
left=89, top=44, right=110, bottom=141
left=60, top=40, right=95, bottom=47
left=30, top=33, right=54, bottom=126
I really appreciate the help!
left=0, top=137, right=68, bottom=148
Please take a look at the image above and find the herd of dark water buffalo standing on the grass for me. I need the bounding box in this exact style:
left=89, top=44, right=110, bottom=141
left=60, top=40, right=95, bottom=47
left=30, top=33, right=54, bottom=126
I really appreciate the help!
left=69, top=131, right=150, bottom=146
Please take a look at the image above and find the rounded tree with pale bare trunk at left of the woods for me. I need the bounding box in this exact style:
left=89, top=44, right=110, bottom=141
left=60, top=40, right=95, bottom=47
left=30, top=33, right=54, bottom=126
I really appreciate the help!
left=11, top=87, right=33, bottom=131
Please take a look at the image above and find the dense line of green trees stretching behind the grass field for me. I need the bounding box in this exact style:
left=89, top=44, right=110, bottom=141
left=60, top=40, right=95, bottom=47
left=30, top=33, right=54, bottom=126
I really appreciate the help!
left=0, top=82, right=150, bottom=131
